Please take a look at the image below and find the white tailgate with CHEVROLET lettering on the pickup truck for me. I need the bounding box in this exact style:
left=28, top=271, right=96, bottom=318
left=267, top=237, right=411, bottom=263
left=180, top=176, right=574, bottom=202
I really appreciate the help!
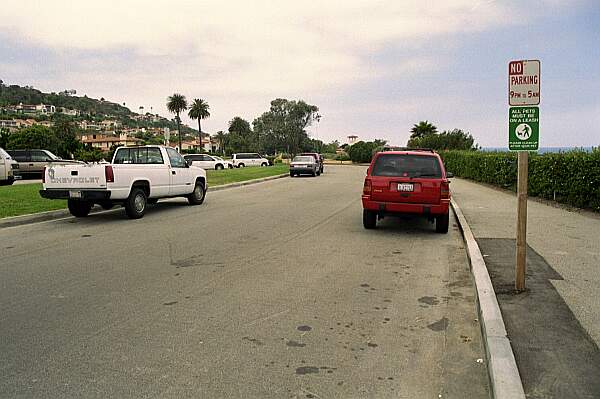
left=44, top=164, right=106, bottom=190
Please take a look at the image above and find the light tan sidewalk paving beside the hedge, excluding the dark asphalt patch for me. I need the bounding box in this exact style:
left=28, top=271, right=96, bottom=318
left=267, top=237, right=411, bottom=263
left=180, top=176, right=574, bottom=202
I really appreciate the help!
left=451, top=179, right=600, bottom=346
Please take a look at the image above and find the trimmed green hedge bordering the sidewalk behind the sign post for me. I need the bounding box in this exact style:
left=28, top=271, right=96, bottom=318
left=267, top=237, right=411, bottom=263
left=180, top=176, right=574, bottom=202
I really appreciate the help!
left=440, top=148, right=600, bottom=212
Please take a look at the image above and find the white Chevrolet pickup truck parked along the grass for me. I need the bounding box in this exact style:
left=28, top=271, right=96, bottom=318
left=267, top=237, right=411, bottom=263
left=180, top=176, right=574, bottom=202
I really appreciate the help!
left=40, top=146, right=207, bottom=219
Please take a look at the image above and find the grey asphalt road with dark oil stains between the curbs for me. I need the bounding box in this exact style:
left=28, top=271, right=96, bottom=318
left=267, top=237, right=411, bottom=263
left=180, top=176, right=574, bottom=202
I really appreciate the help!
left=0, top=166, right=489, bottom=398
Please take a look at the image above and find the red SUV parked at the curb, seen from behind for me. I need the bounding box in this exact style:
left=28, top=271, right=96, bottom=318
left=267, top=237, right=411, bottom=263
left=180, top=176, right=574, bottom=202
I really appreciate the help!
left=362, top=149, right=452, bottom=233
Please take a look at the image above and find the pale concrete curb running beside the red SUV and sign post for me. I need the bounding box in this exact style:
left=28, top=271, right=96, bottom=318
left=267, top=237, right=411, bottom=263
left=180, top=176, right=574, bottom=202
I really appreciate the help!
left=451, top=200, right=525, bottom=399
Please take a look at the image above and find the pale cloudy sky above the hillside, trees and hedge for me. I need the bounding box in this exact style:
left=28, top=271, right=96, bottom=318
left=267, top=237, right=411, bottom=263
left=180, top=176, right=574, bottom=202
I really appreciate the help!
left=0, top=0, right=600, bottom=147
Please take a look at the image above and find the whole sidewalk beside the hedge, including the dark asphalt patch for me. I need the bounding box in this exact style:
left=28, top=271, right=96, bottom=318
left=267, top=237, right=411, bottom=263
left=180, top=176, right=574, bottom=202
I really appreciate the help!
left=451, top=179, right=600, bottom=399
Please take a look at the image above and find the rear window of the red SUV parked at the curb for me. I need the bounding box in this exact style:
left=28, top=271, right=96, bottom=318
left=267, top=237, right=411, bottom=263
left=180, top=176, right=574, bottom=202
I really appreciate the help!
left=371, top=154, right=442, bottom=178
